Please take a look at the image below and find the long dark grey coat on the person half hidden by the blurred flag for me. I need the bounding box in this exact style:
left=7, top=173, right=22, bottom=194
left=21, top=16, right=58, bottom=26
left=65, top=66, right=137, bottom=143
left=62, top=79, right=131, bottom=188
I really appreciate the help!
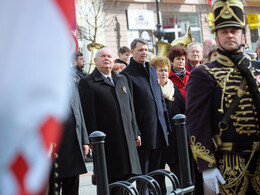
left=56, top=81, right=89, bottom=178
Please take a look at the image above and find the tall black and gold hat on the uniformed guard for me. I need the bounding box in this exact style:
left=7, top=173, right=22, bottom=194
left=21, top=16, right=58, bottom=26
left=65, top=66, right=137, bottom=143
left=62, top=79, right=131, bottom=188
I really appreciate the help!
left=211, top=0, right=245, bottom=33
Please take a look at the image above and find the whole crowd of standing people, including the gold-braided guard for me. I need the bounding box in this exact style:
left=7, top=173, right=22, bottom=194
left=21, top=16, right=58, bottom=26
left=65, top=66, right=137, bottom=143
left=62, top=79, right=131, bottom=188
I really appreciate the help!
left=50, top=0, right=260, bottom=194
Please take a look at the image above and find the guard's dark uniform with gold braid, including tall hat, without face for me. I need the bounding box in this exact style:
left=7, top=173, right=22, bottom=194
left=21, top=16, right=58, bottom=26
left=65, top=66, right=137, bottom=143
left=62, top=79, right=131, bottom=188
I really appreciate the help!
left=186, top=0, right=260, bottom=194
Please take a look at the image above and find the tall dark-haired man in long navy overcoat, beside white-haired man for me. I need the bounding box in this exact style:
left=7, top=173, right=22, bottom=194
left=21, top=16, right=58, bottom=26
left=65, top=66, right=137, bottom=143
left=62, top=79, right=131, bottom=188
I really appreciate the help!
left=121, top=38, right=171, bottom=177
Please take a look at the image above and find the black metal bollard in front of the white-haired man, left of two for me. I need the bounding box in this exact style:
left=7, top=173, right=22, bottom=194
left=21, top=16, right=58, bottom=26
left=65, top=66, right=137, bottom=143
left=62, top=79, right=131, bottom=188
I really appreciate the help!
left=89, top=131, right=109, bottom=195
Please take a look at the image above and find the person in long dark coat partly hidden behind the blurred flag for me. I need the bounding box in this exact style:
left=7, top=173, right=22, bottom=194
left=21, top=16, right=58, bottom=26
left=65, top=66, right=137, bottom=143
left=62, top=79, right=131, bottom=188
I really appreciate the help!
left=49, top=79, right=89, bottom=195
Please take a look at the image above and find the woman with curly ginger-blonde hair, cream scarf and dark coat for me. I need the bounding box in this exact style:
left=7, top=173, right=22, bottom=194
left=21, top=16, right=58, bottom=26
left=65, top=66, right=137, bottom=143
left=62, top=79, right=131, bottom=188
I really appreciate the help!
left=150, top=56, right=185, bottom=194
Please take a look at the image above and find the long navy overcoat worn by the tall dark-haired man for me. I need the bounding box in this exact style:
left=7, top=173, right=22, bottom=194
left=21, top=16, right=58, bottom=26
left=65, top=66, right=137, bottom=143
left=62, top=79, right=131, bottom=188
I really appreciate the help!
left=121, top=58, right=171, bottom=149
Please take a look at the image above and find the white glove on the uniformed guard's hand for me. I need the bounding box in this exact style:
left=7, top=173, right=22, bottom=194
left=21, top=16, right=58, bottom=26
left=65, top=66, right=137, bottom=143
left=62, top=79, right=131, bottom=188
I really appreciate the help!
left=202, top=168, right=225, bottom=194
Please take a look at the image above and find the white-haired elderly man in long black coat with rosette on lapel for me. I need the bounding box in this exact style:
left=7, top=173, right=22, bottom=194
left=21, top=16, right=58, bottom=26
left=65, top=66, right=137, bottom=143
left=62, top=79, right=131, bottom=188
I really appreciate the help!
left=79, top=48, right=141, bottom=183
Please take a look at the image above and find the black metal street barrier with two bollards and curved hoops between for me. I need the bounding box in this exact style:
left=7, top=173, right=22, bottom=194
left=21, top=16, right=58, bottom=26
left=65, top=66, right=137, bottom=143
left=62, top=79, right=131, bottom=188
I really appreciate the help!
left=89, top=114, right=194, bottom=195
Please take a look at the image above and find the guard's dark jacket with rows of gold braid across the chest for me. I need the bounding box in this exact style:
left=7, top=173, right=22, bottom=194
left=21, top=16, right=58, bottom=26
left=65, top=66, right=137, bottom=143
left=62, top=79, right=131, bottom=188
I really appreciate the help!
left=186, top=54, right=260, bottom=171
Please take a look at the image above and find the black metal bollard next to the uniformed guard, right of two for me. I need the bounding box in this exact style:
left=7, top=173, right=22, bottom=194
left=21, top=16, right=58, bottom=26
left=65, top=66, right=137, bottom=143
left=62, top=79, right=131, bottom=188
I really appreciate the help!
left=172, top=114, right=192, bottom=188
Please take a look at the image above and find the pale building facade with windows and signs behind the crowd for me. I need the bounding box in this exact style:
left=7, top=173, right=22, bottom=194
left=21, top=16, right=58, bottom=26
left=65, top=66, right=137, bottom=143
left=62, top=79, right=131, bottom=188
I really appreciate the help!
left=76, top=0, right=260, bottom=70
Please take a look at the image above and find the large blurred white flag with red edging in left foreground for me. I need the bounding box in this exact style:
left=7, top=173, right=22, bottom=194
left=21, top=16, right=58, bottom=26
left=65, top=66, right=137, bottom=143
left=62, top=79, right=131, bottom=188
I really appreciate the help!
left=0, top=0, right=74, bottom=195
